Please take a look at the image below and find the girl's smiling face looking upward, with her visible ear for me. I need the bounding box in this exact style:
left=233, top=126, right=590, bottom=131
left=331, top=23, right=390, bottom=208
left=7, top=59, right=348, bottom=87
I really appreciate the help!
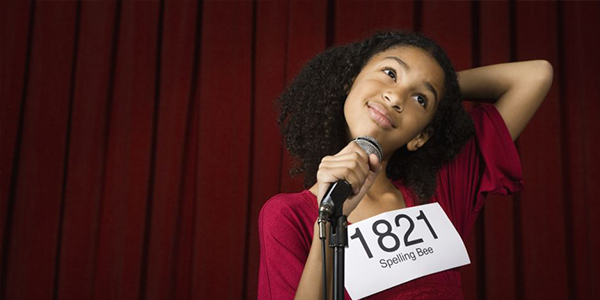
left=344, top=46, right=444, bottom=160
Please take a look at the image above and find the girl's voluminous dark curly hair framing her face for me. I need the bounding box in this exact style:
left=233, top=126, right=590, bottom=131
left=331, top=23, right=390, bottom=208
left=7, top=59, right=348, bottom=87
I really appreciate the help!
left=275, top=31, right=474, bottom=203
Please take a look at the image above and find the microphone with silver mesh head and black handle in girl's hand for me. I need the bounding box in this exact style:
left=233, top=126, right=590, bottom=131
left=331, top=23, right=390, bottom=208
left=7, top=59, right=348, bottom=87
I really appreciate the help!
left=318, top=136, right=382, bottom=239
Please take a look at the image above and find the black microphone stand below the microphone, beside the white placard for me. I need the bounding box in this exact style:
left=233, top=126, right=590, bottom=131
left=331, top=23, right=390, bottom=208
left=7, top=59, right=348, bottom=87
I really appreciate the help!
left=329, top=209, right=348, bottom=300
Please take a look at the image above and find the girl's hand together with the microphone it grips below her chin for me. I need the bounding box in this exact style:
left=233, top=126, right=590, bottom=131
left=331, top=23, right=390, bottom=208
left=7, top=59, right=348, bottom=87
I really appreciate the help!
left=317, top=137, right=381, bottom=234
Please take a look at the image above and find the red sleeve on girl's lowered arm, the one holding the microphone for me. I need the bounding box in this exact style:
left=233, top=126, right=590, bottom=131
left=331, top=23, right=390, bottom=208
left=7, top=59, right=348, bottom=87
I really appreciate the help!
left=258, top=194, right=316, bottom=299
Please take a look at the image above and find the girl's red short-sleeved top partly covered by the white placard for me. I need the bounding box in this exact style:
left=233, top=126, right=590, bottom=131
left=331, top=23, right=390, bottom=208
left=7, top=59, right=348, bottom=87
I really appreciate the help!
left=258, top=105, right=523, bottom=300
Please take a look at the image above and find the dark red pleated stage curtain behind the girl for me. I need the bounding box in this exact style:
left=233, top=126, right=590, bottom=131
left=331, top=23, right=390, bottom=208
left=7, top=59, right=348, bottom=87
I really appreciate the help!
left=0, top=0, right=600, bottom=300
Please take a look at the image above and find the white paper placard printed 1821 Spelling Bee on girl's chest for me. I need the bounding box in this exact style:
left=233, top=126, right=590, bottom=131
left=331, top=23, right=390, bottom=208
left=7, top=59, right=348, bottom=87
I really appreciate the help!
left=344, top=203, right=471, bottom=299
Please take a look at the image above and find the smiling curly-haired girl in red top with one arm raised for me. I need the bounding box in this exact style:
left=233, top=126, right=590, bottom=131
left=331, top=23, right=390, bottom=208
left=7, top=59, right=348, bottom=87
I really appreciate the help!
left=258, top=31, right=552, bottom=299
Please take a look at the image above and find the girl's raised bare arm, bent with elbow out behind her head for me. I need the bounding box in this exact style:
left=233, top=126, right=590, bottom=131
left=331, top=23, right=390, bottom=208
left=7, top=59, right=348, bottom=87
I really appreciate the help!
left=458, top=60, right=553, bottom=141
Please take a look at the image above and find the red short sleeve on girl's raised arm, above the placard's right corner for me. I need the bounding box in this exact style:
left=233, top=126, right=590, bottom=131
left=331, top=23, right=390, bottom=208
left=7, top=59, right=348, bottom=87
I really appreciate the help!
left=434, top=105, right=523, bottom=237
